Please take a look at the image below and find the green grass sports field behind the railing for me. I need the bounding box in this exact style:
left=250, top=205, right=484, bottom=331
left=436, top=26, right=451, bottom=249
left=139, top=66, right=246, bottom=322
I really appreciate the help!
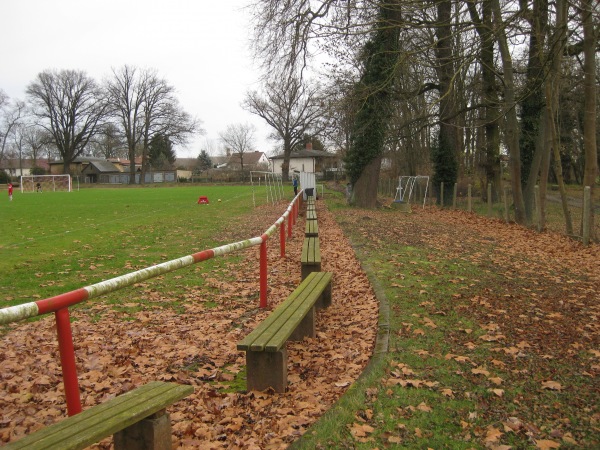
left=0, top=186, right=266, bottom=307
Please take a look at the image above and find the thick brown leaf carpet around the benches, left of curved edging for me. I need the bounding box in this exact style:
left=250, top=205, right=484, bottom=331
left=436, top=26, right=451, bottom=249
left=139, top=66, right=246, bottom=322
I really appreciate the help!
left=0, top=201, right=378, bottom=449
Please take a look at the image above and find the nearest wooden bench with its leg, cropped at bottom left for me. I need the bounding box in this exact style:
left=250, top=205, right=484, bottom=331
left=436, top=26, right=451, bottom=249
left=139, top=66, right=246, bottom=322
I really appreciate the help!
left=7, top=381, right=194, bottom=450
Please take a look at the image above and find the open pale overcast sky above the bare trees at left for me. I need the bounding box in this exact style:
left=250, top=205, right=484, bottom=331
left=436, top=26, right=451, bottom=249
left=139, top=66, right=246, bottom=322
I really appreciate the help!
left=0, top=0, right=274, bottom=157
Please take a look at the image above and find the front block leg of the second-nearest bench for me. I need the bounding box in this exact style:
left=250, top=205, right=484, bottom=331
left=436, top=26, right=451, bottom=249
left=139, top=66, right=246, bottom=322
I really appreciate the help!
left=246, top=347, right=287, bottom=393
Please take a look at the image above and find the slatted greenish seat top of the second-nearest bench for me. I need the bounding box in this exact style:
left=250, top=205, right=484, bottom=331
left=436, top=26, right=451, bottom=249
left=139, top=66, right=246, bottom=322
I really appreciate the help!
left=237, top=274, right=331, bottom=351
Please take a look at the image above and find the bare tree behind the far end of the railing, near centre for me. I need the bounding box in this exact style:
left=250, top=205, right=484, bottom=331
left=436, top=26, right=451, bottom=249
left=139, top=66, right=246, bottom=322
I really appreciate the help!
left=243, top=75, right=324, bottom=180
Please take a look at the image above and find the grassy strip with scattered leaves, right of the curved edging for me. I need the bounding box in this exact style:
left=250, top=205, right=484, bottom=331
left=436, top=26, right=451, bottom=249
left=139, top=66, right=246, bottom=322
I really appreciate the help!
left=292, top=192, right=599, bottom=449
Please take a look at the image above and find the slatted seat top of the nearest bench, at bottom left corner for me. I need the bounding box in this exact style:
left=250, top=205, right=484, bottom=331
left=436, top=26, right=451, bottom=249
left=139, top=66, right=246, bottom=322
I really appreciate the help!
left=4, top=381, right=194, bottom=450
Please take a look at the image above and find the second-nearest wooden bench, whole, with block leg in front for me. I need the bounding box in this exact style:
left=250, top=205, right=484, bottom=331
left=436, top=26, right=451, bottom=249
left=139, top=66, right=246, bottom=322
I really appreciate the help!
left=237, top=272, right=333, bottom=393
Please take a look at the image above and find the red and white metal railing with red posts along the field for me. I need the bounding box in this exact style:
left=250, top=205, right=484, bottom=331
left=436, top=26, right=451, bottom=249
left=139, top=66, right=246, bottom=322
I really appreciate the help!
left=0, top=191, right=302, bottom=416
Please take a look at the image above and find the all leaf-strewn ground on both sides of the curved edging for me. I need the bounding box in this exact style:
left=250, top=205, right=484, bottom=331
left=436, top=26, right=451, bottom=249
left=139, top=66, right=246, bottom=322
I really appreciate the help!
left=0, top=195, right=600, bottom=450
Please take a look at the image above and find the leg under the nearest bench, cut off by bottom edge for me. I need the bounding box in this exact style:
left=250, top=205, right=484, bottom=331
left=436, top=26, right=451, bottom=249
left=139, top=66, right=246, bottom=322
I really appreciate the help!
left=113, top=409, right=173, bottom=450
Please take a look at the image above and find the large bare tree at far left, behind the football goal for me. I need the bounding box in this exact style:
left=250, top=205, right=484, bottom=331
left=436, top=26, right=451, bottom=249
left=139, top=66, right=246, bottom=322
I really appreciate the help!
left=27, top=70, right=108, bottom=173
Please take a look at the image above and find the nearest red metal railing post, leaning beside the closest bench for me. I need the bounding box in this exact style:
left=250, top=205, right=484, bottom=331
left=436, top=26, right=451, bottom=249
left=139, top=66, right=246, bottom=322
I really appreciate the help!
left=54, top=308, right=81, bottom=416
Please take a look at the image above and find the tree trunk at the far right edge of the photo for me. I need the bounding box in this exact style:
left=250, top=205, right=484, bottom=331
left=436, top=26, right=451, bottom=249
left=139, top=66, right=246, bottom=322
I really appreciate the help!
left=580, top=0, right=598, bottom=240
